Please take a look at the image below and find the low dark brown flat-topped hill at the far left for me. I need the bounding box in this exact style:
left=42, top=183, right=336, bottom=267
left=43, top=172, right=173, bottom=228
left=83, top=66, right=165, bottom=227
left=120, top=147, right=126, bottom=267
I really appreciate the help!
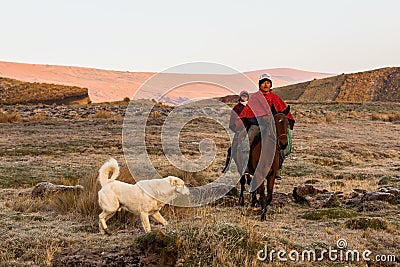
left=0, top=77, right=90, bottom=105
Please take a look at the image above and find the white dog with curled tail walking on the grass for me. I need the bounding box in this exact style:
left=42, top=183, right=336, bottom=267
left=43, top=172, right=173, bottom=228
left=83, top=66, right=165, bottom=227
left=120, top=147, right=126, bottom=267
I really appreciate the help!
left=98, top=158, right=190, bottom=235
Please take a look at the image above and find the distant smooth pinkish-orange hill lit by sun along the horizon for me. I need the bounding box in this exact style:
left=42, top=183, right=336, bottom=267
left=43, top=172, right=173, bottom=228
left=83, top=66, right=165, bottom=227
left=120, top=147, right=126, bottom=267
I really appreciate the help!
left=0, top=62, right=332, bottom=103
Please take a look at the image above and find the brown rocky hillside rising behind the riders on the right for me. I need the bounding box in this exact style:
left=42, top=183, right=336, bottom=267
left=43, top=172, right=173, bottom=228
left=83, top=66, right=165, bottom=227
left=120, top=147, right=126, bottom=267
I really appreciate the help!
left=275, top=67, right=400, bottom=102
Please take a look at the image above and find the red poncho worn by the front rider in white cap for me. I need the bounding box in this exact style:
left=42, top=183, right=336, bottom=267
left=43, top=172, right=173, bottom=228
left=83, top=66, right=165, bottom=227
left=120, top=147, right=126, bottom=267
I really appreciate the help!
left=239, top=90, right=295, bottom=130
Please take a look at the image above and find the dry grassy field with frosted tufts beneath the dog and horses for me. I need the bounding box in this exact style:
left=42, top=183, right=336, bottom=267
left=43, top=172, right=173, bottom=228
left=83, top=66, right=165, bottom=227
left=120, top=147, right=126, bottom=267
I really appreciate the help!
left=0, top=102, right=400, bottom=266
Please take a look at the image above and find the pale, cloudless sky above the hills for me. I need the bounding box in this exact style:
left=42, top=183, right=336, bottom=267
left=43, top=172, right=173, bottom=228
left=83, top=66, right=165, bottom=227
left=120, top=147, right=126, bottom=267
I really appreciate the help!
left=0, top=0, right=400, bottom=73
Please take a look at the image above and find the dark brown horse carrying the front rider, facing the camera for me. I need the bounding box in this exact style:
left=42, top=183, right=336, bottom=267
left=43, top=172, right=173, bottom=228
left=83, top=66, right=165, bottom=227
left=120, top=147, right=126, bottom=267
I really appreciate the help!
left=239, top=106, right=290, bottom=221
